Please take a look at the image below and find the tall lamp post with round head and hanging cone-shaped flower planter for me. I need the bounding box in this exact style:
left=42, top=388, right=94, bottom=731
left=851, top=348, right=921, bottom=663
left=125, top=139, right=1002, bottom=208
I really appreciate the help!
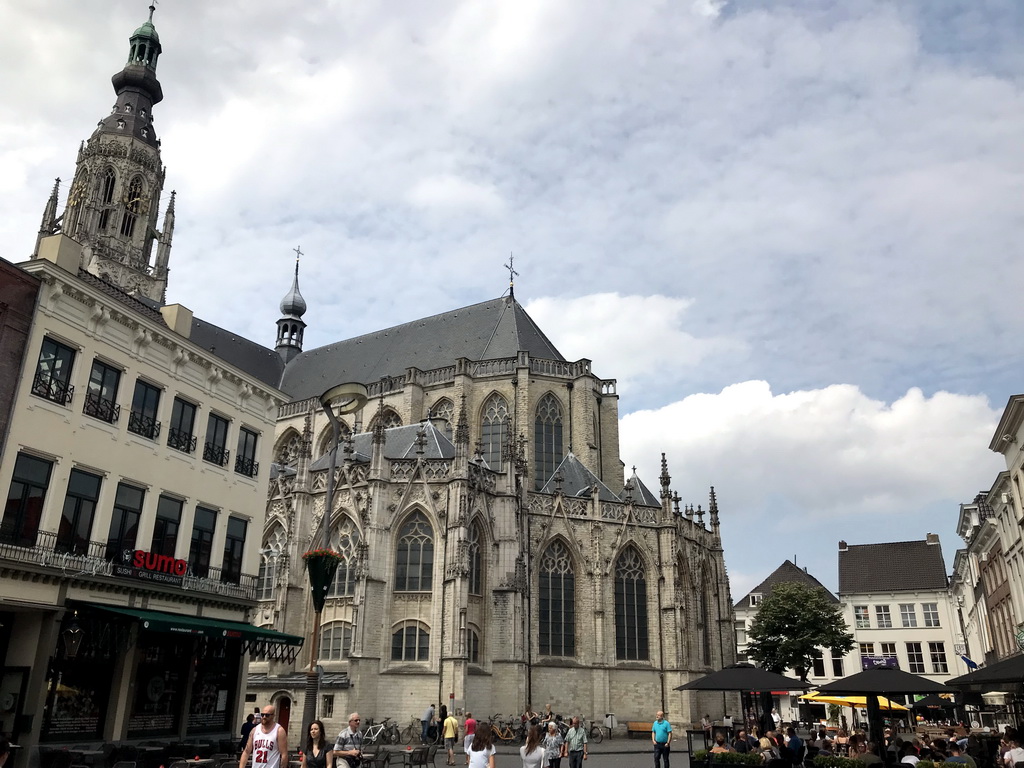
left=298, top=382, right=368, bottom=743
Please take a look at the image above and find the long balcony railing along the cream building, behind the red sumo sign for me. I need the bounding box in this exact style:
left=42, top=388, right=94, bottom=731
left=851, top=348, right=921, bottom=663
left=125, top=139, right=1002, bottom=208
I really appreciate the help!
left=0, top=530, right=257, bottom=600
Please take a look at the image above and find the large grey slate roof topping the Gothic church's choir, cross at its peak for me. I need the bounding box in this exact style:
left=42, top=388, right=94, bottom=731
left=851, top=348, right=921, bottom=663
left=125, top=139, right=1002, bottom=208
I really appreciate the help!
left=281, top=297, right=565, bottom=400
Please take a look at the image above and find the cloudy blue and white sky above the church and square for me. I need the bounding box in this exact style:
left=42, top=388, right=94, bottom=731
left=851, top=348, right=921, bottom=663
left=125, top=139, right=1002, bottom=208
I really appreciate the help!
left=0, top=0, right=1024, bottom=600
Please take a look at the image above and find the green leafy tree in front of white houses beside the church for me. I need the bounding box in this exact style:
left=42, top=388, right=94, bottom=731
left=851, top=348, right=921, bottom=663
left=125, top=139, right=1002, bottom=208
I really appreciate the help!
left=746, top=582, right=853, bottom=681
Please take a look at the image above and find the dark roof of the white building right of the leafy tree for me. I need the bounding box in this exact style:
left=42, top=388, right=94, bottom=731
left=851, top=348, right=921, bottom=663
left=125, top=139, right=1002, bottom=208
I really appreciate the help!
left=839, top=537, right=948, bottom=595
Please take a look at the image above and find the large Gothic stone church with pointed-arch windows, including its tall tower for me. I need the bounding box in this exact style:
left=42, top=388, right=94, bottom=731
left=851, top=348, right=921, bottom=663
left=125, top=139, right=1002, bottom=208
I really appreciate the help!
left=18, top=4, right=735, bottom=733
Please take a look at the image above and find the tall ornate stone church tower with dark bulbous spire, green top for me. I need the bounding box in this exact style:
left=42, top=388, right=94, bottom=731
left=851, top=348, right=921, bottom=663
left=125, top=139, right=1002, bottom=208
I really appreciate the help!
left=33, top=5, right=174, bottom=302
